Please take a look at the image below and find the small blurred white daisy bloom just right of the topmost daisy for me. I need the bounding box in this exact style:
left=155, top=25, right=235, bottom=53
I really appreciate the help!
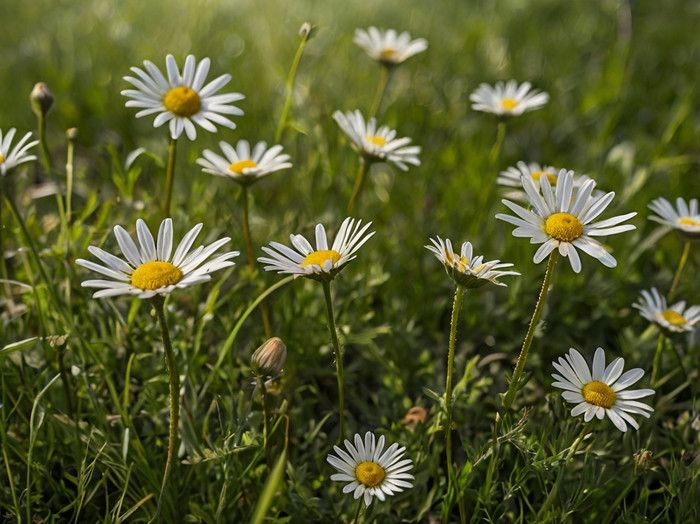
left=469, top=80, right=549, bottom=116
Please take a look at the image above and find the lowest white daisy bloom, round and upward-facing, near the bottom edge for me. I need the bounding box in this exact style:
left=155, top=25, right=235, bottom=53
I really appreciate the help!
left=326, top=431, right=414, bottom=506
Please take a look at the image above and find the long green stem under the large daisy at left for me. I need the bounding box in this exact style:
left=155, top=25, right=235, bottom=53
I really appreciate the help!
left=153, top=295, right=180, bottom=516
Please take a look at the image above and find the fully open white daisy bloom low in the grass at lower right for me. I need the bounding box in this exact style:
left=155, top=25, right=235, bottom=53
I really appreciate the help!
left=552, top=348, right=654, bottom=432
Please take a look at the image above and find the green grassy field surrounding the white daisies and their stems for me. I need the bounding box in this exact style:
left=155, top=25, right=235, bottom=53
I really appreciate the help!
left=0, top=0, right=700, bottom=524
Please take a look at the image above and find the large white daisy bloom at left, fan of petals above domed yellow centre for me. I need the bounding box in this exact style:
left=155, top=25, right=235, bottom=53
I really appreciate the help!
left=75, top=218, right=239, bottom=298
